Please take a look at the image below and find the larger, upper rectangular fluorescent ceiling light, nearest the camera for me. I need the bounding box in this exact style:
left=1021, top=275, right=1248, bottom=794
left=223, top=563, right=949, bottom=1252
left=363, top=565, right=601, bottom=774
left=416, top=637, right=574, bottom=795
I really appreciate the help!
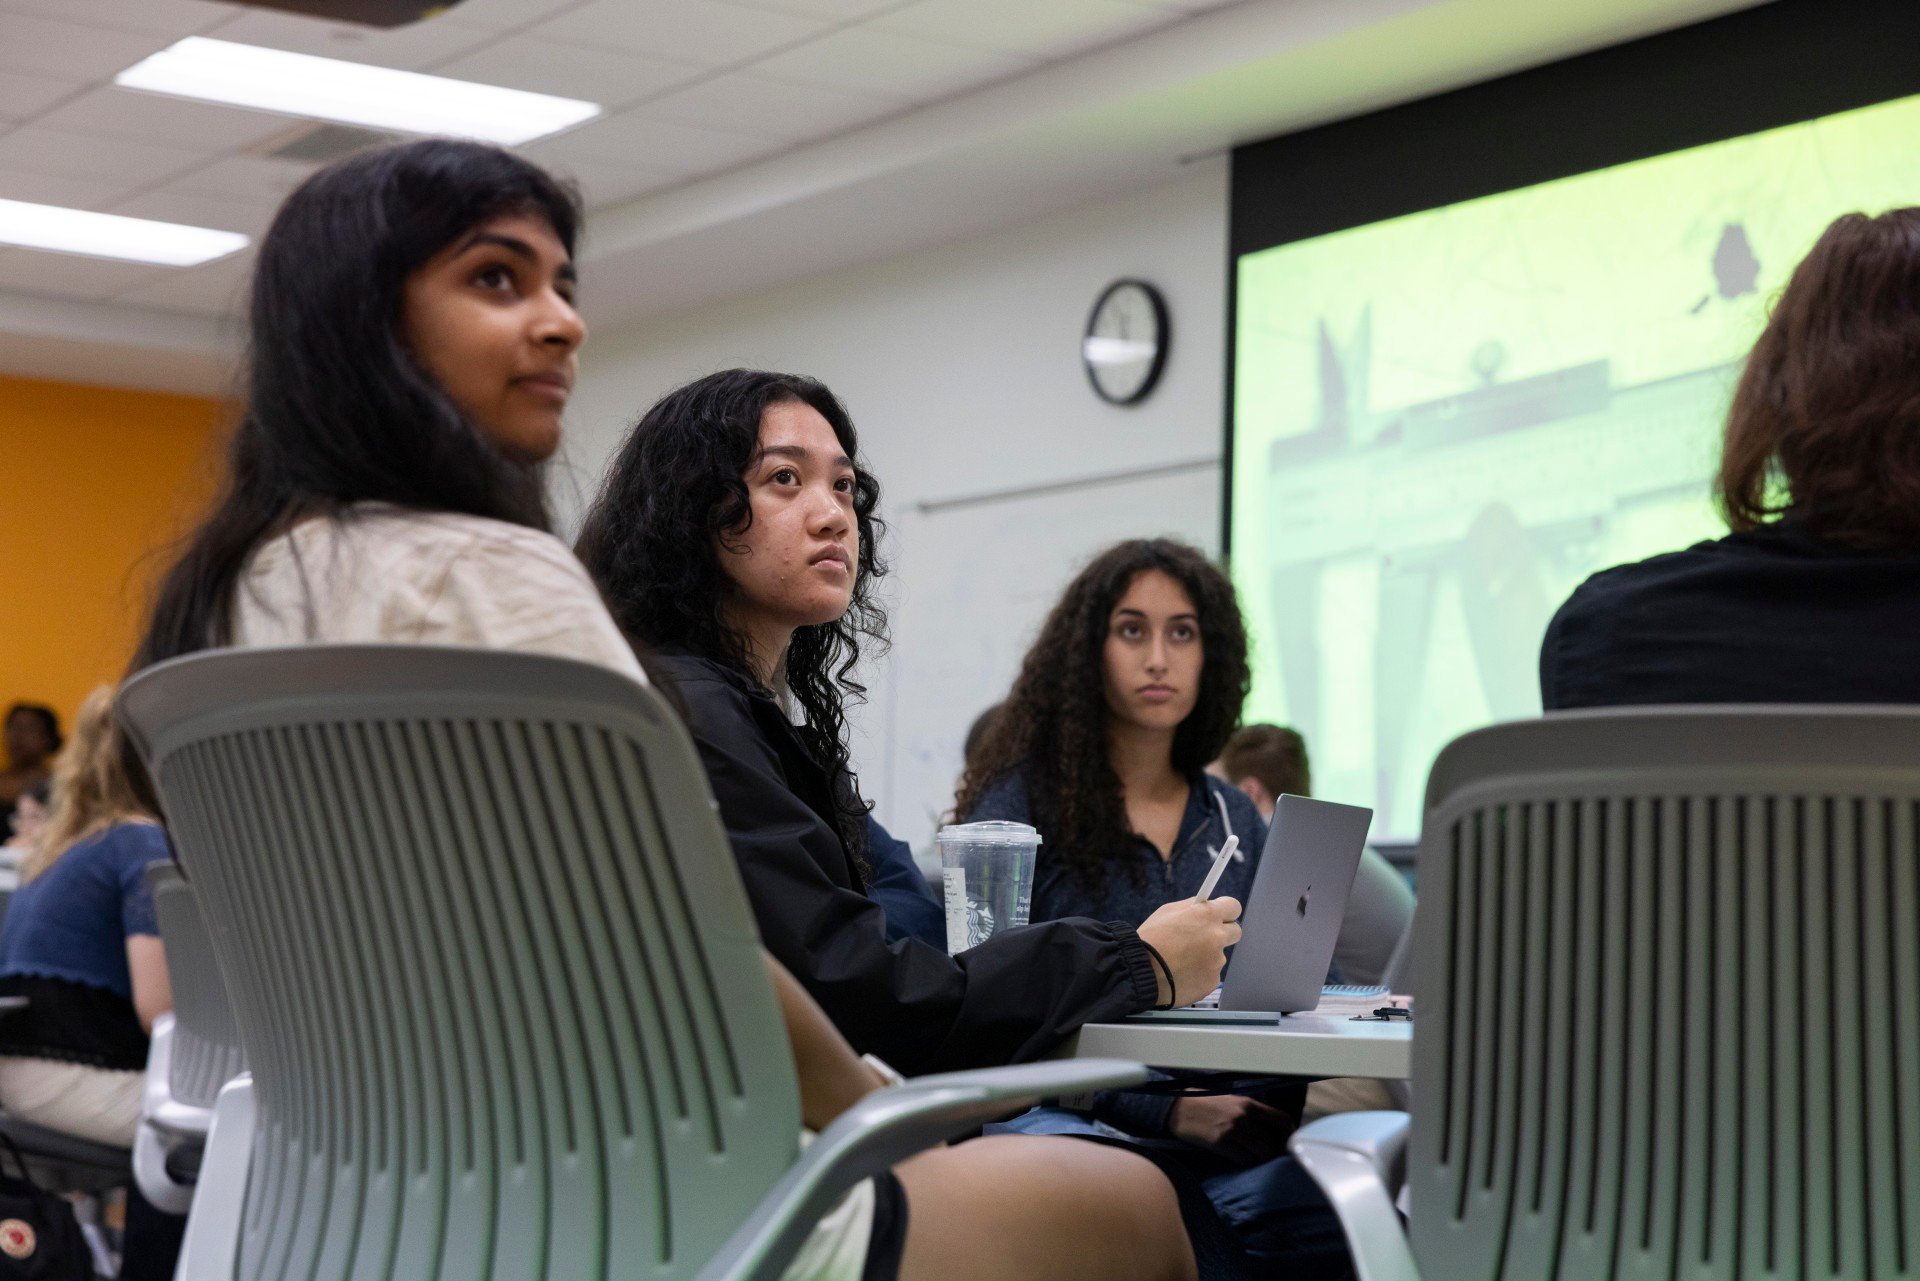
left=113, top=36, right=601, bottom=146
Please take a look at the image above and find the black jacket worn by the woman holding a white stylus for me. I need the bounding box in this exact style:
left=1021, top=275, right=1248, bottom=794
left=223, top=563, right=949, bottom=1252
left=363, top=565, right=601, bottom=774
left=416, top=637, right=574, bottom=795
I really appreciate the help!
left=649, top=651, right=1156, bottom=1076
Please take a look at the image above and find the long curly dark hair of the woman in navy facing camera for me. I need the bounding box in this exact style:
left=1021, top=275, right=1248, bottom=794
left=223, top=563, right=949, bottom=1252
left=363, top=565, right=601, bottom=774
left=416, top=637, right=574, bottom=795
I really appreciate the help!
left=954, top=538, right=1248, bottom=887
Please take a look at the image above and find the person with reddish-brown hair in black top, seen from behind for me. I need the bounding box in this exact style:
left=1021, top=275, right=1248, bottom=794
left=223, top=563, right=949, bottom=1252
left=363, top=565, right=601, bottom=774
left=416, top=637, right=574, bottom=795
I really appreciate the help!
left=1540, top=207, right=1920, bottom=711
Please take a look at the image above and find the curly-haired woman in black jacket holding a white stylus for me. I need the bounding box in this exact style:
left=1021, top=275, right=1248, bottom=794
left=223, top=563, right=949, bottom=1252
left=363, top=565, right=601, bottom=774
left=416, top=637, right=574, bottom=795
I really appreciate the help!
left=578, top=369, right=1240, bottom=1076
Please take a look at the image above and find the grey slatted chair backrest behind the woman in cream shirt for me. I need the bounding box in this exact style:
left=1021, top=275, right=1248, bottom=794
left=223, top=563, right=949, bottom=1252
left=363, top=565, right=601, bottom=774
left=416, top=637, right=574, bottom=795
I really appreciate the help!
left=123, top=645, right=799, bottom=1281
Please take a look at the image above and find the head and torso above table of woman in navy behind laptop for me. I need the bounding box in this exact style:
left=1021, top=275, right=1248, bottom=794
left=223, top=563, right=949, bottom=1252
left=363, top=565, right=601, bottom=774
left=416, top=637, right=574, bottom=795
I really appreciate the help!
left=954, top=538, right=1267, bottom=920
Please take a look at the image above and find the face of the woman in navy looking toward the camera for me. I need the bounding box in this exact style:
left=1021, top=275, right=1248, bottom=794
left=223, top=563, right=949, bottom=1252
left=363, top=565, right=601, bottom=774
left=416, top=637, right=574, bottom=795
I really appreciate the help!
left=1102, top=568, right=1206, bottom=730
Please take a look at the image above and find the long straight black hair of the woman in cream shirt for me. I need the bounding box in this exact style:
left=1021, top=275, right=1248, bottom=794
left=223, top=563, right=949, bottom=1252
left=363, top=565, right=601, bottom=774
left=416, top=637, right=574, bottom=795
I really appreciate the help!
left=132, top=138, right=580, bottom=668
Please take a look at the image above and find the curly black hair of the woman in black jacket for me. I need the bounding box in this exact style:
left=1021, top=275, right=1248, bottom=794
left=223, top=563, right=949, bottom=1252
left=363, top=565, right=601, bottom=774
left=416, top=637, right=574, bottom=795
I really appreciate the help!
left=576, top=369, right=887, bottom=872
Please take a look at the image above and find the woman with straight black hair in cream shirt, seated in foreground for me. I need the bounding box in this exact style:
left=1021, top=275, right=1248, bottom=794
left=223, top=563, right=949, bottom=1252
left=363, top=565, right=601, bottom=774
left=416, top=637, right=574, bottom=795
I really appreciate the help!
left=136, top=140, right=1192, bottom=1281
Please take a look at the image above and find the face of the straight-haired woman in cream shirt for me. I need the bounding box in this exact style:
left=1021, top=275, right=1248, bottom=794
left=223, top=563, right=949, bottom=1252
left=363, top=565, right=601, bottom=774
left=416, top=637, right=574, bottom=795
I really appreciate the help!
left=401, top=213, right=588, bottom=463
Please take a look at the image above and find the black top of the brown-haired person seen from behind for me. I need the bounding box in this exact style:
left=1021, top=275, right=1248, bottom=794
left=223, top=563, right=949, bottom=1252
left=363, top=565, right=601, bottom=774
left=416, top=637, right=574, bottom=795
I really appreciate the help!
left=1540, top=520, right=1920, bottom=711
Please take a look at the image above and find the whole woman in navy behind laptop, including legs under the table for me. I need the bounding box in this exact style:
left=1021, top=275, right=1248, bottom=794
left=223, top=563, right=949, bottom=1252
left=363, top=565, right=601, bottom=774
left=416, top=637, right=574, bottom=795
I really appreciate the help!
left=954, top=538, right=1350, bottom=1277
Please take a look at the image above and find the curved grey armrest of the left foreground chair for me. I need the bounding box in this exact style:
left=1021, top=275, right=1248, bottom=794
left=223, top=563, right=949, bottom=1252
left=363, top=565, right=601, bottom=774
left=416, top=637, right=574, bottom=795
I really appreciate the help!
left=699, top=1058, right=1148, bottom=1281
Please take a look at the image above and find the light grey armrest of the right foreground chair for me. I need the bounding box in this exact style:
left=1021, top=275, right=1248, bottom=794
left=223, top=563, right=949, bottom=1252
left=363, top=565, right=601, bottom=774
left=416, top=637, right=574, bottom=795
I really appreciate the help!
left=1286, top=1112, right=1421, bottom=1281
